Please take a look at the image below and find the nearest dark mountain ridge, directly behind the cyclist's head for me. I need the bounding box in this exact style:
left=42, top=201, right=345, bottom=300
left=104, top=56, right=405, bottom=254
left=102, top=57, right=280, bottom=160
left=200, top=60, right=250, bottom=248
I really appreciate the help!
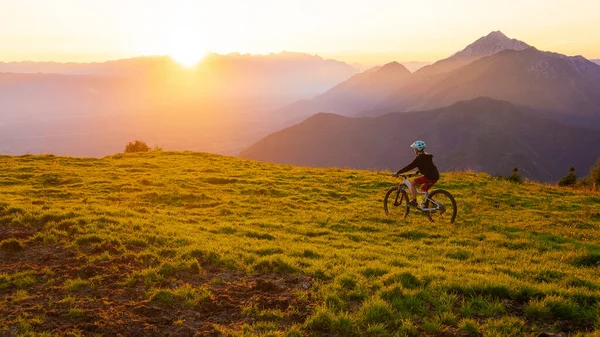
left=241, top=97, right=600, bottom=181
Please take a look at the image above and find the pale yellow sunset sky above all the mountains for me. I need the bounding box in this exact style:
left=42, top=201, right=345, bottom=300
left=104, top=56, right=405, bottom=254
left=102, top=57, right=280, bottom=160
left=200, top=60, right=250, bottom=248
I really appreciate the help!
left=0, top=0, right=600, bottom=64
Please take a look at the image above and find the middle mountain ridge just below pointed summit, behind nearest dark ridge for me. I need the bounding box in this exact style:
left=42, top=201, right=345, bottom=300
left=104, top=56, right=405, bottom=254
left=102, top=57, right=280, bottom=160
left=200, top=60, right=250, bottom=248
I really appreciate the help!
left=378, top=47, right=600, bottom=116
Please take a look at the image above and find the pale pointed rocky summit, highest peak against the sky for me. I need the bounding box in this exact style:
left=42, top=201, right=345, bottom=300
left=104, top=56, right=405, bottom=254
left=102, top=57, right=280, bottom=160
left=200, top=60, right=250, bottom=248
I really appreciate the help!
left=451, top=30, right=531, bottom=59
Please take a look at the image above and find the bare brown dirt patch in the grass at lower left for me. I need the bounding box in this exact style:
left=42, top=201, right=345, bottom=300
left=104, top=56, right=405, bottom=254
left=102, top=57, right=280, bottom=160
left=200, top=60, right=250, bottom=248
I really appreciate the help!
left=0, top=240, right=315, bottom=336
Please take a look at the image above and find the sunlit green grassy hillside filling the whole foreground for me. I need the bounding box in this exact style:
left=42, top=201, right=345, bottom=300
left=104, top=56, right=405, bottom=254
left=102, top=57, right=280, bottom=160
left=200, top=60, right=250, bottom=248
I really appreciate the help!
left=0, top=152, right=600, bottom=336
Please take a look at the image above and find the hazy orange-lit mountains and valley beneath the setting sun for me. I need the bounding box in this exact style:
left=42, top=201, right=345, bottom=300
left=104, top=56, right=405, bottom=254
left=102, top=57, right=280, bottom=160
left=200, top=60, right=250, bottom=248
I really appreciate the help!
left=0, top=53, right=358, bottom=156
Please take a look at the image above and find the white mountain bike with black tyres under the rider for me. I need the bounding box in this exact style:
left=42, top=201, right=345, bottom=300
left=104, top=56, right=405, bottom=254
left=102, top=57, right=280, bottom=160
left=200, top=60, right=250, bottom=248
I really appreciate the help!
left=383, top=174, right=456, bottom=223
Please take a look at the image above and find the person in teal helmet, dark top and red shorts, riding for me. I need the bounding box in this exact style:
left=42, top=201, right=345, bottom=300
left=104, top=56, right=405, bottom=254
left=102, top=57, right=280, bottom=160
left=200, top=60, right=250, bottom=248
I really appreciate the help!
left=394, top=140, right=440, bottom=207
